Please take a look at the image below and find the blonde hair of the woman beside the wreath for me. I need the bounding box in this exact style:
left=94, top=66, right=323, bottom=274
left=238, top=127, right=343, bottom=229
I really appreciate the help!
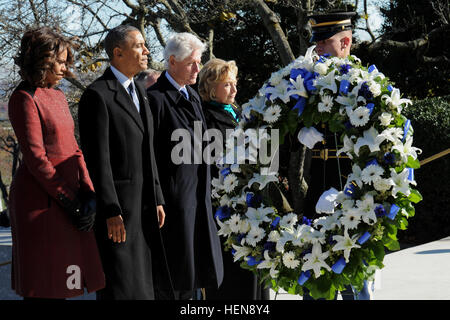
left=198, top=59, right=238, bottom=101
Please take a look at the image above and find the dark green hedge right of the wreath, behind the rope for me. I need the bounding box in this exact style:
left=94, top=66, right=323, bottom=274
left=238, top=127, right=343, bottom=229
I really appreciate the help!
left=398, top=95, right=450, bottom=244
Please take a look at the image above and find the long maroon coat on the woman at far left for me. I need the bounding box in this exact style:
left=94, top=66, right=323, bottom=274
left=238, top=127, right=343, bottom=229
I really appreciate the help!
left=8, top=82, right=105, bottom=298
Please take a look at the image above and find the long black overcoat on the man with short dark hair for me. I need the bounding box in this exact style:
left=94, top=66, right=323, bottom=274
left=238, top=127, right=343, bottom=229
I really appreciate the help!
left=78, top=68, right=170, bottom=299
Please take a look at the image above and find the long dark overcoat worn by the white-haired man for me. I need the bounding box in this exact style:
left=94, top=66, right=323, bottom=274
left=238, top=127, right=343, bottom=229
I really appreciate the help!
left=147, top=72, right=223, bottom=291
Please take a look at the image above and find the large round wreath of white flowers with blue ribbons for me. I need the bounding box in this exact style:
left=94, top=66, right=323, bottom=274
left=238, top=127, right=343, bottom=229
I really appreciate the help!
left=212, top=47, right=422, bottom=299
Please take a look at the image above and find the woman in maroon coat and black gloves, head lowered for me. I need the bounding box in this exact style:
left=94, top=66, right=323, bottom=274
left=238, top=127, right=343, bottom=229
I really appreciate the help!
left=8, top=27, right=105, bottom=299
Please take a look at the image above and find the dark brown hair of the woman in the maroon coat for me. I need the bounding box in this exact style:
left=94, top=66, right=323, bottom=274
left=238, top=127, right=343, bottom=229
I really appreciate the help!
left=14, top=27, right=75, bottom=87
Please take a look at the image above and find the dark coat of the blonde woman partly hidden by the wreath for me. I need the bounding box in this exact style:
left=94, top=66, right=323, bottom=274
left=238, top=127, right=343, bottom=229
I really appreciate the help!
left=203, top=102, right=270, bottom=300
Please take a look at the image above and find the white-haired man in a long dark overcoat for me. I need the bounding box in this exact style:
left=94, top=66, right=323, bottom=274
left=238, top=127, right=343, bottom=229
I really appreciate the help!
left=147, top=33, right=223, bottom=299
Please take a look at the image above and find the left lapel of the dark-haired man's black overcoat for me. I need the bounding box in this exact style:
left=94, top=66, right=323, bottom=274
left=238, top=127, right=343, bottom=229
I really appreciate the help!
left=105, top=68, right=144, bottom=132
